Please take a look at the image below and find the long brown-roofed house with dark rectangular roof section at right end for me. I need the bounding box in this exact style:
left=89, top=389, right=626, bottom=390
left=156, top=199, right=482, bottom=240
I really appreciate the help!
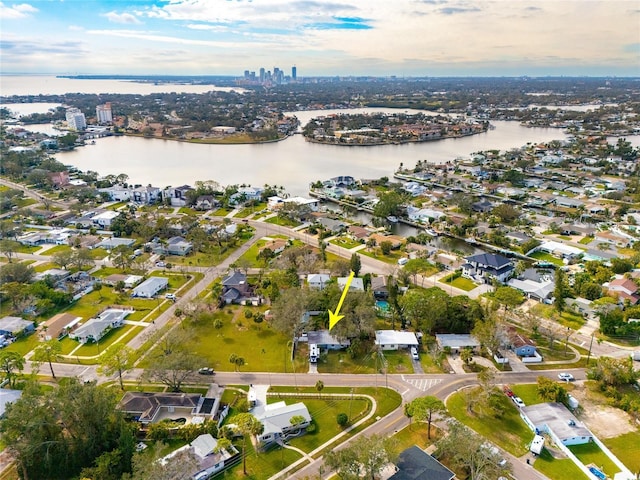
left=117, top=392, right=220, bottom=424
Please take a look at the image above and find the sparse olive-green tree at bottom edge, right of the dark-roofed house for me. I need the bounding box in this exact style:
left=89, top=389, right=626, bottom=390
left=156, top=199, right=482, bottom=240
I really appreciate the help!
left=437, top=420, right=510, bottom=480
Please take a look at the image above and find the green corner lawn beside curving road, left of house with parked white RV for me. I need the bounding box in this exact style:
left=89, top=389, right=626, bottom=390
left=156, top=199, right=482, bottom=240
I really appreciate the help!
left=447, top=391, right=534, bottom=457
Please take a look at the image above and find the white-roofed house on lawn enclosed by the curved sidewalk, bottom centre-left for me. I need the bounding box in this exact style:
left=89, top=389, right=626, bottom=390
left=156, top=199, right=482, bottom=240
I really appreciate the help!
left=251, top=401, right=312, bottom=447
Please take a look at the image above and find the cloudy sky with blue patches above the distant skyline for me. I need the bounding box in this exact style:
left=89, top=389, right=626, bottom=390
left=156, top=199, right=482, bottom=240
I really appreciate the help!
left=0, top=0, right=640, bottom=77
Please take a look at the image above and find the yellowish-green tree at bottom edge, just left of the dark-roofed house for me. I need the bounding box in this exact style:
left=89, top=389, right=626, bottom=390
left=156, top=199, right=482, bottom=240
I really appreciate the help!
left=324, top=435, right=397, bottom=480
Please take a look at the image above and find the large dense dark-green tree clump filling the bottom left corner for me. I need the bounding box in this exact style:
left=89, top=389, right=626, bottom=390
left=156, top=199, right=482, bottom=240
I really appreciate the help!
left=1, top=378, right=135, bottom=480
